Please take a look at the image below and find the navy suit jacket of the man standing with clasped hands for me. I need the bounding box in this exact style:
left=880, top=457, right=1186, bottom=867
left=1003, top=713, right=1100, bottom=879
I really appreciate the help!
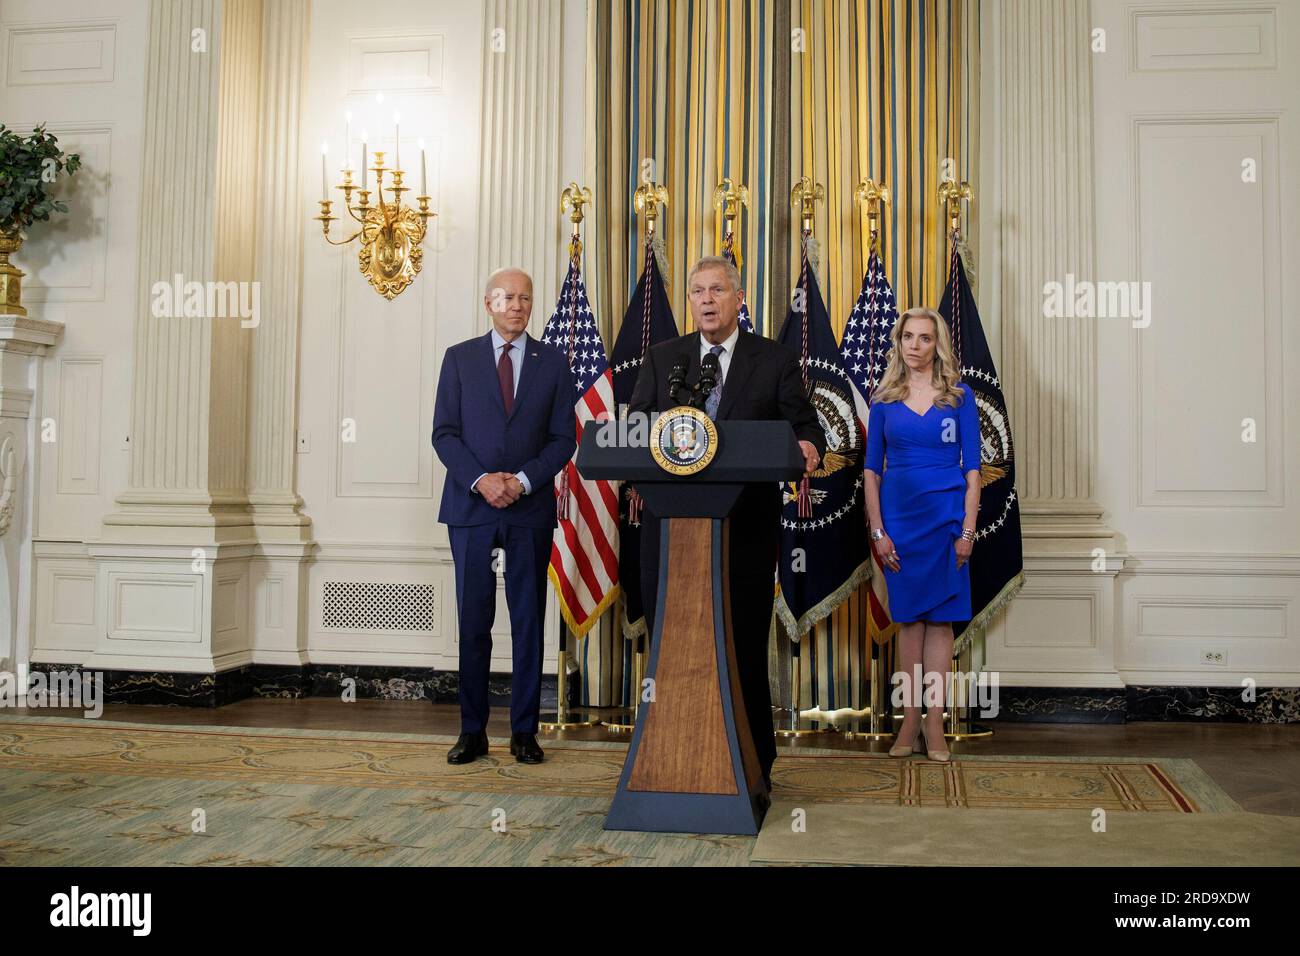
left=433, top=332, right=577, bottom=528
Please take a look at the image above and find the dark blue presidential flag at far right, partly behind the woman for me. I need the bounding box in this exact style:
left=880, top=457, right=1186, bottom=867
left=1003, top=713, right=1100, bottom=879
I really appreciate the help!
left=939, top=242, right=1024, bottom=653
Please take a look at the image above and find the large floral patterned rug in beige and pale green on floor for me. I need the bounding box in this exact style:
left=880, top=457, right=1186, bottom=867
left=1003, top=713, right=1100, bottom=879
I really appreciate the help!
left=0, top=715, right=1240, bottom=866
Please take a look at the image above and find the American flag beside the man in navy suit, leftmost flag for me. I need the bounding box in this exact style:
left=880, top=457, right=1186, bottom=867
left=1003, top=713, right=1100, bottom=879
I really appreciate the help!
left=542, top=259, right=619, bottom=637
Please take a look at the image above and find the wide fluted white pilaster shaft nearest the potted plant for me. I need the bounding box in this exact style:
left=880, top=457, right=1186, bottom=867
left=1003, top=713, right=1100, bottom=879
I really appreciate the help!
left=104, top=0, right=263, bottom=527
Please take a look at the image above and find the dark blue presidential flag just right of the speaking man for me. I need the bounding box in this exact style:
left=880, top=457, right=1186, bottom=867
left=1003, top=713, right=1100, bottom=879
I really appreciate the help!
left=776, top=242, right=871, bottom=640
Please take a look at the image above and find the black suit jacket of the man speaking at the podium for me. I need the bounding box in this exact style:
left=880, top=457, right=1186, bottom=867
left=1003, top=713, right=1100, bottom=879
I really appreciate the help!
left=628, top=332, right=826, bottom=460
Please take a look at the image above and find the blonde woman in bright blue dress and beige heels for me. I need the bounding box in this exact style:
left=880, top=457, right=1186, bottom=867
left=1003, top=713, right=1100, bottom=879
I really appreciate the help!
left=865, top=308, right=980, bottom=761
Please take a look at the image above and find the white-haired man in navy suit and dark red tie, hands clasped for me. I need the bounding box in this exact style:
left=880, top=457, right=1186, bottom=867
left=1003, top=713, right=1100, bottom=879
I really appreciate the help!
left=433, top=268, right=577, bottom=763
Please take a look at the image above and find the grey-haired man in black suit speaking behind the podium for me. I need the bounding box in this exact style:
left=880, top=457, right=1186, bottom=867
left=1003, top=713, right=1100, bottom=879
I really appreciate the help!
left=629, top=256, right=826, bottom=786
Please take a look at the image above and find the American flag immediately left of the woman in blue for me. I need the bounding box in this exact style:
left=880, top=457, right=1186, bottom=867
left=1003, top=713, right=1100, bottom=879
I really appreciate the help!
left=840, top=250, right=898, bottom=641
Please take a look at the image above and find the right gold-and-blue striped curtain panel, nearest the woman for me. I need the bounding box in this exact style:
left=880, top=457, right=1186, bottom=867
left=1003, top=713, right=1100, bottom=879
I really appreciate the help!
left=789, top=0, right=979, bottom=334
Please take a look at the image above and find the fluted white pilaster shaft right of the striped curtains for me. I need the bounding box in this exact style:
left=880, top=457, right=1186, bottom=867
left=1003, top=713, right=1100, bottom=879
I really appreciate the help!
left=976, top=0, right=1109, bottom=538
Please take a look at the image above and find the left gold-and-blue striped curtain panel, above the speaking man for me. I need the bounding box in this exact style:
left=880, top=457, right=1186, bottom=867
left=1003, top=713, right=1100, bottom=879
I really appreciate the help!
left=586, top=0, right=785, bottom=341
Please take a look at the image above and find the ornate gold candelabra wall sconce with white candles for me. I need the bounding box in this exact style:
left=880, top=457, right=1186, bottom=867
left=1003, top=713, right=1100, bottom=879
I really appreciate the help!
left=313, top=143, right=437, bottom=302
